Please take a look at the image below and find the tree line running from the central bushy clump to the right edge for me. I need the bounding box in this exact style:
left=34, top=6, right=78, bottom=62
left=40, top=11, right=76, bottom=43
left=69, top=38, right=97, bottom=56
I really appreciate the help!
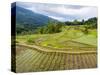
left=37, top=17, right=97, bottom=34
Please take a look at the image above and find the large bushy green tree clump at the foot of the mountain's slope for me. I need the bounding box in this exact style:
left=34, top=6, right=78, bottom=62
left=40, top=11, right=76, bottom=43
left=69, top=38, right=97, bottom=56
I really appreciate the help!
left=37, top=21, right=64, bottom=34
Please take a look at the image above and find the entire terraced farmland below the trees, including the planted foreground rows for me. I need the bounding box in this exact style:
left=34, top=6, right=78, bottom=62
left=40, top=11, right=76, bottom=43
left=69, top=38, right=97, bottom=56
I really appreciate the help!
left=16, top=26, right=97, bottom=72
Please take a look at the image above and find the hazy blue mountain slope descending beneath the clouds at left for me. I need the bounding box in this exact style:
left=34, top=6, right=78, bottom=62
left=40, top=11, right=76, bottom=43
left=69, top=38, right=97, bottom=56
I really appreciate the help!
left=11, top=4, right=57, bottom=33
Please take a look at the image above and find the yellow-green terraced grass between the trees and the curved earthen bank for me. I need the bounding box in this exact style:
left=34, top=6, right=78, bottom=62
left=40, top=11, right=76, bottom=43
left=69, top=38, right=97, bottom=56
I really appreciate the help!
left=16, top=26, right=97, bottom=48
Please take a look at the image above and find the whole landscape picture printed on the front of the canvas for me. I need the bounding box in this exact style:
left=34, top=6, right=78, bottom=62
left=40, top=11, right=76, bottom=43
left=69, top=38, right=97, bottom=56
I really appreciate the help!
left=12, top=2, right=97, bottom=72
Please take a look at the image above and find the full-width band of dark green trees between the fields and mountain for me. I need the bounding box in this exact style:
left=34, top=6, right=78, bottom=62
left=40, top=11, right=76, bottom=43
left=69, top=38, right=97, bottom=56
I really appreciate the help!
left=16, top=17, right=97, bottom=34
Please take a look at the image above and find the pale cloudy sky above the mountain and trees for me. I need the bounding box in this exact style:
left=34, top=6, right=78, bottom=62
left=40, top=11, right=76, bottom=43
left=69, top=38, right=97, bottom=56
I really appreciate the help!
left=17, top=2, right=97, bottom=21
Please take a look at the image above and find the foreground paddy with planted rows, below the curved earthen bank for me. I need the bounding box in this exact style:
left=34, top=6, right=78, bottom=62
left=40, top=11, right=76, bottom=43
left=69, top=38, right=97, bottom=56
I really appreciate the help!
left=16, top=46, right=97, bottom=72
